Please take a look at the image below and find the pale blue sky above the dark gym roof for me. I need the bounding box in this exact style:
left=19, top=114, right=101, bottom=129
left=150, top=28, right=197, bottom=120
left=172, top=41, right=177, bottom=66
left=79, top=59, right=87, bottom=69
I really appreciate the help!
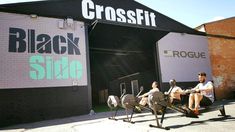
left=0, top=0, right=235, bottom=28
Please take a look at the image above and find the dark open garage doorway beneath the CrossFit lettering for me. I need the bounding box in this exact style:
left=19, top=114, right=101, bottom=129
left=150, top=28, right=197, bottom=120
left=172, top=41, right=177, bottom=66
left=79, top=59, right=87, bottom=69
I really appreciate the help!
left=89, top=23, right=167, bottom=105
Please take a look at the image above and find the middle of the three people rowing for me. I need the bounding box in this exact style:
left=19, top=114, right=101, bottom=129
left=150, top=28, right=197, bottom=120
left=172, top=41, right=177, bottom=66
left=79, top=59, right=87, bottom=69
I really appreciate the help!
left=165, top=79, right=185, bottom=105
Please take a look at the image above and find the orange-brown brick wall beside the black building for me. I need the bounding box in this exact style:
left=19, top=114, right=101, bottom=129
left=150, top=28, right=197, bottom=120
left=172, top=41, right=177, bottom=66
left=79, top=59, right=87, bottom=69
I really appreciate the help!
left=205, top=18, right=235, bottom=99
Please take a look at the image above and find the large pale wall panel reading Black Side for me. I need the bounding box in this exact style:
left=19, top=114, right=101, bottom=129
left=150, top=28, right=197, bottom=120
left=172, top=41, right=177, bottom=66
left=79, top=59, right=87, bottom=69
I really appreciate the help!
left=0, top=13, right=87, bottom=88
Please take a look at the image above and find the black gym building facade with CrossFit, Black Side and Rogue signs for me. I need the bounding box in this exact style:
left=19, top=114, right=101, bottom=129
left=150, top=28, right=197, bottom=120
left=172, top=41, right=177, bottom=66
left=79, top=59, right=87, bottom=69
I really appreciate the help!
left=0, top=0, right=211, bottom=126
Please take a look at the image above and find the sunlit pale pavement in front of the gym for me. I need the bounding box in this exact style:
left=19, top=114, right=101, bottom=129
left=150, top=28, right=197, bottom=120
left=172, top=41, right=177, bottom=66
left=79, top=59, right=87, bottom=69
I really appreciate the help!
left=0, top=100, right=235, bottom=132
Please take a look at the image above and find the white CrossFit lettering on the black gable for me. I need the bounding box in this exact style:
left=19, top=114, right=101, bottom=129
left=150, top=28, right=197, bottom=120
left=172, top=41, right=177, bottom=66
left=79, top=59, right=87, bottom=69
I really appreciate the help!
left=82, top=0, right=156, bottom=27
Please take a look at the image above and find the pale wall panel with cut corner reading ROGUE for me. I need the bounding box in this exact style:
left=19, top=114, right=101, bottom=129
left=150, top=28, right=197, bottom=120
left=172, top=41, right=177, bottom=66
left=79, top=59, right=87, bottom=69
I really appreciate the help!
left=157, top=33, right=212, bottom=82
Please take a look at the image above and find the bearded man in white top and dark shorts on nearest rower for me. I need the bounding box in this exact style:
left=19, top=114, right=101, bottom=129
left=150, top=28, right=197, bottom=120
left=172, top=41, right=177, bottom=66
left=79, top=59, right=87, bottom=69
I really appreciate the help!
left=189, top=72, right=214, bottom=115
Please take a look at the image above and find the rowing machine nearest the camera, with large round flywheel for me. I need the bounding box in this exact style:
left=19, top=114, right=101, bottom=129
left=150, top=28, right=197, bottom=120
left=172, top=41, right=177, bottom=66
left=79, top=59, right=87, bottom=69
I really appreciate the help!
left=148, top=90, right=226, bottom=130
